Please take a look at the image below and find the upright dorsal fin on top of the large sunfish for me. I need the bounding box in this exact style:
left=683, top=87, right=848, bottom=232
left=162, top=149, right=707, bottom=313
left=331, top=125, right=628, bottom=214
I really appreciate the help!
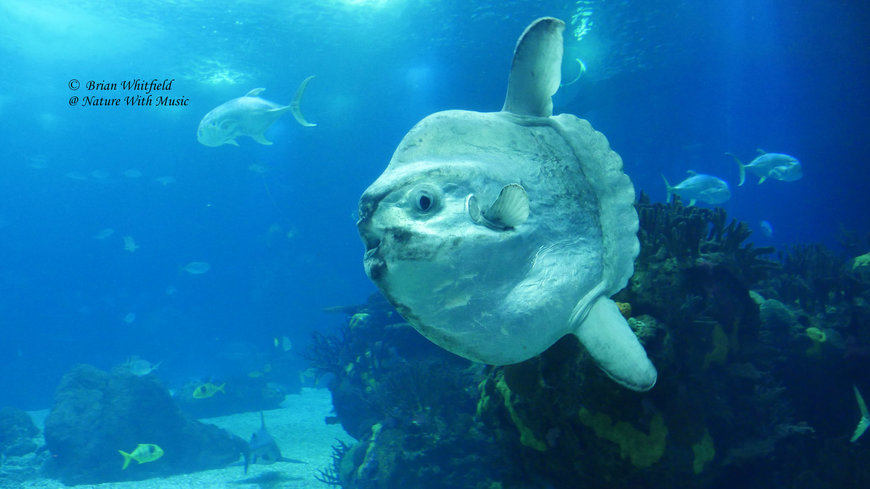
left=502, top=17, right=565, bottom=117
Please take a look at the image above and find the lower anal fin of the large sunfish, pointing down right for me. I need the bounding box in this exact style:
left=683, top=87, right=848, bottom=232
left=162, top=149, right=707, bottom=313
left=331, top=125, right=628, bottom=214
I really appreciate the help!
left=574, top=297, right=658, bottom=391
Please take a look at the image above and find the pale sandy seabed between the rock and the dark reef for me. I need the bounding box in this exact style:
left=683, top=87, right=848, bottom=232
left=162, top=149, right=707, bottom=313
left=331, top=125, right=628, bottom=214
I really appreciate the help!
left=20, top=388, right=353, bottom=489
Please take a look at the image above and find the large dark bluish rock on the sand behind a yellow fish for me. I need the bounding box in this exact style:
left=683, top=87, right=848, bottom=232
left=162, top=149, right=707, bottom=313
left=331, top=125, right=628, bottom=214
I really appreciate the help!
left=45, top=365, right=247, bottom=484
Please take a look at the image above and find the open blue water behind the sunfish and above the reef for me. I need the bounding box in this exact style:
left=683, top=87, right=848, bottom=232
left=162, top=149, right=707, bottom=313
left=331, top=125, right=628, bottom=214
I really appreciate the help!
left=0, top=0, right=870, bottom=408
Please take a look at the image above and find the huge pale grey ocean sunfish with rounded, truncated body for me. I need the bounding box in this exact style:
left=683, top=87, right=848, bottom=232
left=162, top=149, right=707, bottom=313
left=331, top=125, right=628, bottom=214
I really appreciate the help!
left=357, top=18, right=656, bottom=391
